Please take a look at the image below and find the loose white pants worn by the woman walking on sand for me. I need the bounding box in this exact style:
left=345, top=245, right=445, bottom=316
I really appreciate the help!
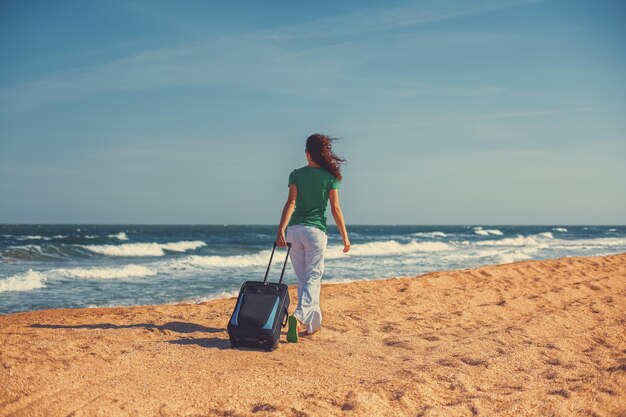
left=285, top=224, right=328, bottom=333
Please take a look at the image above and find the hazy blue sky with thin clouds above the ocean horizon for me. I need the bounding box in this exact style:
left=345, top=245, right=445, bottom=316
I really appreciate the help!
left=0, top=0, right=626, bottom=224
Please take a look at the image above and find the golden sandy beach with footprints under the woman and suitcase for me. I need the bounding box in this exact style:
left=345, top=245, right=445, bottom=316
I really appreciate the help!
left=0, top=254, right=626, bottom=416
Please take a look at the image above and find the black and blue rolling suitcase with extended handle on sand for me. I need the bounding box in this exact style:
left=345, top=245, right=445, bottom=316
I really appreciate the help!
left=228, top=242, right=291, bottom=351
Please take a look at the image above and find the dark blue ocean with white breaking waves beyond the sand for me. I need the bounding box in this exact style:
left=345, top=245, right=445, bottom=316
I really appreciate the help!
left=0, top=225, right=626, bottom=314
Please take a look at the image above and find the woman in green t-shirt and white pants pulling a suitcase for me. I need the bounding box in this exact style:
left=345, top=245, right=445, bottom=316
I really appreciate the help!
left=276, top=133, right=350, bottom=342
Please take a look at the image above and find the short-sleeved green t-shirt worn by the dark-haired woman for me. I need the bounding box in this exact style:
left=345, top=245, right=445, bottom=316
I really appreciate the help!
left=289, top=165, right=339, bottom=233
